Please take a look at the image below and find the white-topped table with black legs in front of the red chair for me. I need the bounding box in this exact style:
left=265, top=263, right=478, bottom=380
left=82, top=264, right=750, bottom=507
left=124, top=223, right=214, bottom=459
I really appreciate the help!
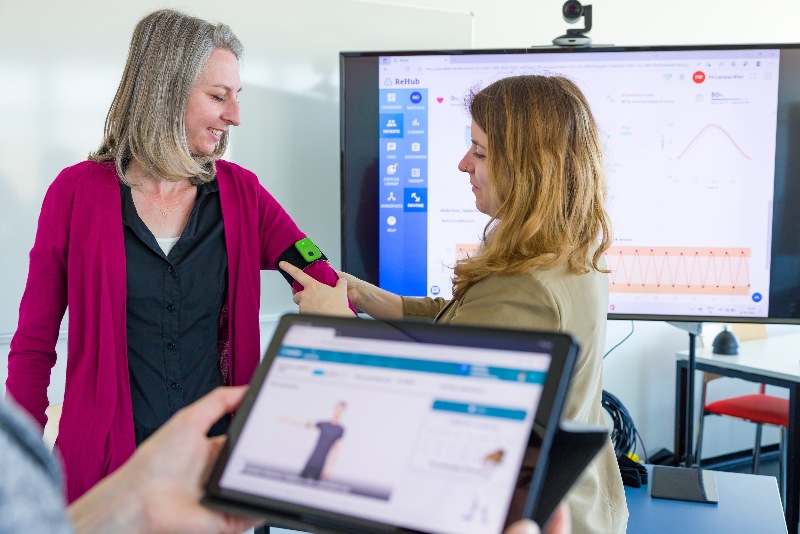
left=675, top=334, right=800, bottom=534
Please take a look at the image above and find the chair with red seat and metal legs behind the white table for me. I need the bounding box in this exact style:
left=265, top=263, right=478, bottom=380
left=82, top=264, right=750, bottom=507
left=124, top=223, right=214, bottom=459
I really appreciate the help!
left=695, top=325, right=789, bottom=504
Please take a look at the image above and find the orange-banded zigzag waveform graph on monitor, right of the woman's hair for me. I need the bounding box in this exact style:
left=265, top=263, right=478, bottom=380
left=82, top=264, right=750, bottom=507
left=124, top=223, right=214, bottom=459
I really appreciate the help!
left=605, top=247, right=750, bottom=295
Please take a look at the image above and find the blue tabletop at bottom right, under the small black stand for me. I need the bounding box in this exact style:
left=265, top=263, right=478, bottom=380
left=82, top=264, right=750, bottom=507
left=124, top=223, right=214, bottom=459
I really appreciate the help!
left=625, top=466, right=786, bottom=534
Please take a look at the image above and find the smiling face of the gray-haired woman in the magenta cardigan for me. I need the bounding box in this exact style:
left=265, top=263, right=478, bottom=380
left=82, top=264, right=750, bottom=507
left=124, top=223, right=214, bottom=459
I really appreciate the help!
left=185, top=48, right=242, bottom=155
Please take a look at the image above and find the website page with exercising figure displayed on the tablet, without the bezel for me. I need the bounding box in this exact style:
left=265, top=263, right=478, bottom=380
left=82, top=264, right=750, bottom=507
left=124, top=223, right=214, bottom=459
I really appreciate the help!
left=220, top=325, right=551, bottom=533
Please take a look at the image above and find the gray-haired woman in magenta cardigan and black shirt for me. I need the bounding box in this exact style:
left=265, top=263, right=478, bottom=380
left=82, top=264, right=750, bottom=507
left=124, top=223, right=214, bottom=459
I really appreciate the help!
left=6, top=10, right=350, bottom=502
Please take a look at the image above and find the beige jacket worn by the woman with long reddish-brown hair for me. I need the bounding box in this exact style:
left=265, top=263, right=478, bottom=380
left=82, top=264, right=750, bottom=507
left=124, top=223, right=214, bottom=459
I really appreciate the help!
left=403, top=266, right=628, bottom=534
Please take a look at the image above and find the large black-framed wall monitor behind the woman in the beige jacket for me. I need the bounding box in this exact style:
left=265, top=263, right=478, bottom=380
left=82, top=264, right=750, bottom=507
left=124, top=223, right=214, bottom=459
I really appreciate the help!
left=341, top=44, right=800, bottom=323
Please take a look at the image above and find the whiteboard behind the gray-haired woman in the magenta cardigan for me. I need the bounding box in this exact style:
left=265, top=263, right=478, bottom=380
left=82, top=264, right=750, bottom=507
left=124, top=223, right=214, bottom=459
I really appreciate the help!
left=0, top=0, right=472, bottom=338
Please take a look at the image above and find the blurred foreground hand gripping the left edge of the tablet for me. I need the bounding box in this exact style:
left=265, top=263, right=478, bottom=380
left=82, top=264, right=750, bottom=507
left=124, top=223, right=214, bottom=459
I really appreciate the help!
left=69, top=387, right=263, bottom=533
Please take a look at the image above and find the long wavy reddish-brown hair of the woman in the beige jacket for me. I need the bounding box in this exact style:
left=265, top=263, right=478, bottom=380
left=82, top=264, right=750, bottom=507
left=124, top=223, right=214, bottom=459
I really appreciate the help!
left=453, top=75, right=612, bottom=299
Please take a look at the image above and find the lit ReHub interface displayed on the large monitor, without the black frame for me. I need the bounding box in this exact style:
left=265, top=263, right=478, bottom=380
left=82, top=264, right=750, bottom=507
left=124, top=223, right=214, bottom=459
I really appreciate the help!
left=377, top=49, right=781, bottom=317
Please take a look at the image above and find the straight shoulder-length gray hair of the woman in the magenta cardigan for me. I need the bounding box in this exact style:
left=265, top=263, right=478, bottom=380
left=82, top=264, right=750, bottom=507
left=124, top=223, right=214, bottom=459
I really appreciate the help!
left=89, top=9, right=243, bottom=183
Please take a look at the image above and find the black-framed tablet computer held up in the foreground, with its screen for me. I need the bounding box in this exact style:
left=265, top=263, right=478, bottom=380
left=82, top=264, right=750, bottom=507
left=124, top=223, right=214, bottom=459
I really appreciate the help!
left=204, top=315, right=577, bottom=534
